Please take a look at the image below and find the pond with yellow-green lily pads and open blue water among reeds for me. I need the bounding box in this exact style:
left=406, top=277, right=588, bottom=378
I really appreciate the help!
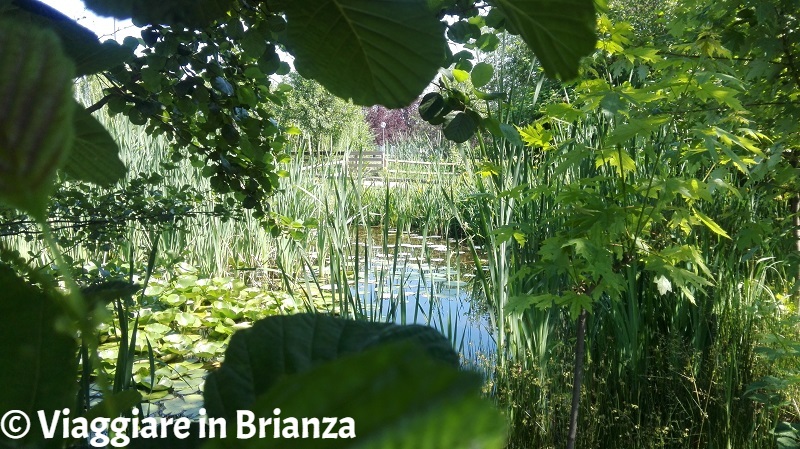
left=101, top=229, right=495, bottom=418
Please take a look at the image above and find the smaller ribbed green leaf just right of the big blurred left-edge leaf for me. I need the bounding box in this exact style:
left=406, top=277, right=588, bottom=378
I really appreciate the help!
left=64, top=106, right=128, bottom=186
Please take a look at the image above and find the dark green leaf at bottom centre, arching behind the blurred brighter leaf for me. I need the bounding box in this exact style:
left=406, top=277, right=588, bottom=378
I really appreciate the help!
left=205, top=314, right=458, bottom=417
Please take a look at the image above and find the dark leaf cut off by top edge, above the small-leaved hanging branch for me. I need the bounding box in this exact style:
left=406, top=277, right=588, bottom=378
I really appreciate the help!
left=85, top=0, right=234, bottom=26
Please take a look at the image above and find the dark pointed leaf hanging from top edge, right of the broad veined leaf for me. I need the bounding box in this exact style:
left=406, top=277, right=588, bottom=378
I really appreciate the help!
left=495, top=0, right=597, bottom=80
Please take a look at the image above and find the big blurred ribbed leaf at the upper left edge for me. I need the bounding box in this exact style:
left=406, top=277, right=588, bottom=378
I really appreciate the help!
left=0, top=20, right=75, bottom=218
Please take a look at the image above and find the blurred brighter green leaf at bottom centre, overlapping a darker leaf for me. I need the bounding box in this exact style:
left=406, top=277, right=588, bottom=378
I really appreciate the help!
left=206, top=342, right=506, bottom=449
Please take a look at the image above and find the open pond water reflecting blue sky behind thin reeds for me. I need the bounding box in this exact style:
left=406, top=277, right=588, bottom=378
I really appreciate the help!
left=298, top=228, right=496, bottom=364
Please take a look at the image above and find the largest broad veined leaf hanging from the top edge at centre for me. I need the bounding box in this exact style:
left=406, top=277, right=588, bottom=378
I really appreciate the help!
left=284, top=0, right=446, bottom=108
